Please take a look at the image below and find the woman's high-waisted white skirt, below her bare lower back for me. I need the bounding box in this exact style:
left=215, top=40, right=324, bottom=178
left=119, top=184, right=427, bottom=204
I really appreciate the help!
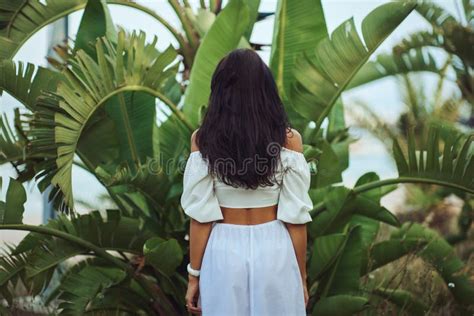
left=198, top=219, right=306, bottom=316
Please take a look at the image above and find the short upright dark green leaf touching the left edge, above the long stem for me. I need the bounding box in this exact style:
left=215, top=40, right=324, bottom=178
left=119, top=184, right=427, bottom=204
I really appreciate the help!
left=0, top=178, right=26, bottom=224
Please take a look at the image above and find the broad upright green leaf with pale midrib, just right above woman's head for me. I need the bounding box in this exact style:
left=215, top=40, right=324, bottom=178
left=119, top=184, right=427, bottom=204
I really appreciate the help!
left=270, top=0, right=328, bottom=101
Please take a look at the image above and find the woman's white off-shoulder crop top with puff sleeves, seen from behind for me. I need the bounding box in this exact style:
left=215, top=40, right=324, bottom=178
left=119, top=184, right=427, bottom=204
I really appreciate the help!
left=180, top=147, right=313, bottom=224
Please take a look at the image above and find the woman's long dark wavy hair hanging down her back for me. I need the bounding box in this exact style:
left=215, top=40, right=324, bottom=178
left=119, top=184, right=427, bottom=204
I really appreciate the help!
left=196, top=48, right=291, bottom=189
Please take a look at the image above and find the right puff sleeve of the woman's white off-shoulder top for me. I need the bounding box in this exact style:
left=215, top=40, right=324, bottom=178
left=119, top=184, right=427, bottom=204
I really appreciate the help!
left=277, top=151, right=313, bottom=224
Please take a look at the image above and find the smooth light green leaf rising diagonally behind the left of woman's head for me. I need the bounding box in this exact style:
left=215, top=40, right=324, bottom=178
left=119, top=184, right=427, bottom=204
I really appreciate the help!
left=183, top=0, right=248, bottom=126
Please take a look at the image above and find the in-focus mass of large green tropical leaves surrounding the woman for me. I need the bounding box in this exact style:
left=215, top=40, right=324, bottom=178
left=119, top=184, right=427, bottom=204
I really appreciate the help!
left=0, top=0, right=474, bottom=315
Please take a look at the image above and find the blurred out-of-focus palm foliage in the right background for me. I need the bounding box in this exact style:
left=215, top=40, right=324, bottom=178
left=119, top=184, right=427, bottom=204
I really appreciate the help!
left=346, top=1, right=474, bottom=251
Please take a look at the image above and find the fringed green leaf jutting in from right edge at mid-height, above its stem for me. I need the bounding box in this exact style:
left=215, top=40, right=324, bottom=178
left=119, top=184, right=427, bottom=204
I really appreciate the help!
left=393, top=125, right=474, bottom=193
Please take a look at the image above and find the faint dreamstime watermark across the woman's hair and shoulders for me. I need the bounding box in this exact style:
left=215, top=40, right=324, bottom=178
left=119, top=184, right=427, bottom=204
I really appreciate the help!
left=143, top=142, right=322, bottom=175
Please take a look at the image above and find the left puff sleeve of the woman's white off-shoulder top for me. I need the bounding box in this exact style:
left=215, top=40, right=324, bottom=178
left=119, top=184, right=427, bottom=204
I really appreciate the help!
left=180, top=151, right=224, bottom=223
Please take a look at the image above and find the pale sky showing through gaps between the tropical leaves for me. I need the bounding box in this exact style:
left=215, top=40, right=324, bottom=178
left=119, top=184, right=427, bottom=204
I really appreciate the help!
left=0, top=0, right=458, bottom=244
